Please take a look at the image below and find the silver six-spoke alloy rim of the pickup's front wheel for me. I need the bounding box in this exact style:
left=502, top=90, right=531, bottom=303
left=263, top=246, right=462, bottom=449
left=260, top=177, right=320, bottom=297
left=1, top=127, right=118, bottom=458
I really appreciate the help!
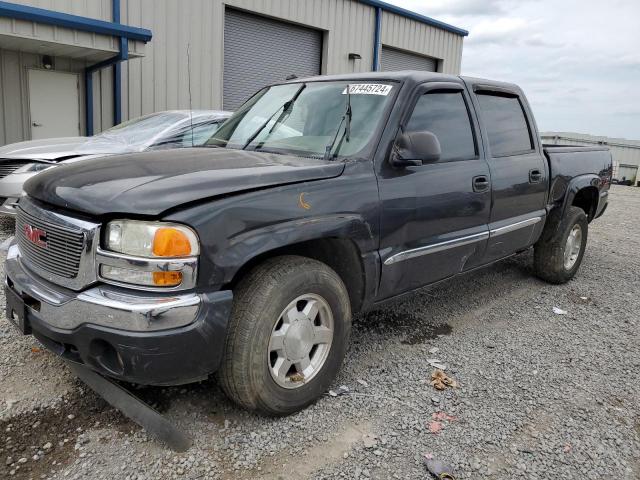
left=267, top=293, right=334, bottom=389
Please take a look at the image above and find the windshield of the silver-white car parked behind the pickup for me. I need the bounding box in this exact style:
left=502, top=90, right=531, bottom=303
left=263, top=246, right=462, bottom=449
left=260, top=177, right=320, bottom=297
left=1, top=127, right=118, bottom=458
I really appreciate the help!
left=80, top=112, right=188, bottom=153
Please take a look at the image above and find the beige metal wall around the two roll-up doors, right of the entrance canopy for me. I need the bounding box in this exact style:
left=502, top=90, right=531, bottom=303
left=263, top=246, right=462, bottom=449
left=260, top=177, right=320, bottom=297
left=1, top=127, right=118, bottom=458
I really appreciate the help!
left=117, top=0, right=463, bottom=119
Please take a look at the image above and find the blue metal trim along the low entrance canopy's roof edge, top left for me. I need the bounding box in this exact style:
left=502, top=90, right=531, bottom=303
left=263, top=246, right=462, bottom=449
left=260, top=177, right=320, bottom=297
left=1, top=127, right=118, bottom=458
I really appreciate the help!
left=0, top=1, right=152, bottom=43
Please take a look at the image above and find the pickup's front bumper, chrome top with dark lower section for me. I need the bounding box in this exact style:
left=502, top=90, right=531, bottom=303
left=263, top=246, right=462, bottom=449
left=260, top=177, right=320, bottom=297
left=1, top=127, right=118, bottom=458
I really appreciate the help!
left=5, top=245, right=233, bottom=385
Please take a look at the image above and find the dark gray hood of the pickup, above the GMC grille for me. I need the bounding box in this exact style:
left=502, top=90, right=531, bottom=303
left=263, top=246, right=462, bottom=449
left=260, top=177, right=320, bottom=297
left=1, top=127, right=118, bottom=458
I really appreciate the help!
left=24, top=148, right=344, bottom=216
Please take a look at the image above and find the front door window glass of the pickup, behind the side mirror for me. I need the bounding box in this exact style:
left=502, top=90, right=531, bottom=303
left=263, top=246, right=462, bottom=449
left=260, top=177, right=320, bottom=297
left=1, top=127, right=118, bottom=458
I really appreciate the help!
left=406, top=92, right=476, bottom=160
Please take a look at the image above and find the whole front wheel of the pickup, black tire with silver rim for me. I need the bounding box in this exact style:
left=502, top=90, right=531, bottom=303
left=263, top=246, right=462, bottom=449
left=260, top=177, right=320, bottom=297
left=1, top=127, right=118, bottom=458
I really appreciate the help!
left=218, top=256, right=351, bottom=415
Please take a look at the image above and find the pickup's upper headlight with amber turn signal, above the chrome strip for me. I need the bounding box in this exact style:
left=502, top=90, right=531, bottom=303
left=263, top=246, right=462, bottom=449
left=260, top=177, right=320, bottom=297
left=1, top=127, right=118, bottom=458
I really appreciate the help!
left=105, top=220, right=200, bottom=257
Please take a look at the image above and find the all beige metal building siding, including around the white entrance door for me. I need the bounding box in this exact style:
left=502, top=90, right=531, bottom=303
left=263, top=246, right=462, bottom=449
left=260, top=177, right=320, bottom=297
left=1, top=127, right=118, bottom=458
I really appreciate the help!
left=0, top=0, right=463, bottom=139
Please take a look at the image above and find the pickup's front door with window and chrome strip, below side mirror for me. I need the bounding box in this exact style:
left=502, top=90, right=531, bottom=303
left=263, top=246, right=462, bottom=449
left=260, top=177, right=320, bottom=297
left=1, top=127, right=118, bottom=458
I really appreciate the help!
left=378, top=82, right=491, bottom=299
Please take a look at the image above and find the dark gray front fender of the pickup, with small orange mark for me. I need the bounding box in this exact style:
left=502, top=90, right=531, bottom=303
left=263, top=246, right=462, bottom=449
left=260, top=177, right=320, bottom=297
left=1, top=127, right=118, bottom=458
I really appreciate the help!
left=166, top=161, right=379, bottom=290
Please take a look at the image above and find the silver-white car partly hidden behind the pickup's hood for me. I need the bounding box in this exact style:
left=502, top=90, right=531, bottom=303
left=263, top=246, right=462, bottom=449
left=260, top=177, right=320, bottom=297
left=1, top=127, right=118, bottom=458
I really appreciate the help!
left=0, top=110, right=231, bottom=215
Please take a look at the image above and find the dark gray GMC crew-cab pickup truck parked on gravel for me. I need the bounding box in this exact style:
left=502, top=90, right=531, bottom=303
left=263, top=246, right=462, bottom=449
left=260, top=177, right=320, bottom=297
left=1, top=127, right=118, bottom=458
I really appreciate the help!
left=5, top=72, right=611, bottom=414
